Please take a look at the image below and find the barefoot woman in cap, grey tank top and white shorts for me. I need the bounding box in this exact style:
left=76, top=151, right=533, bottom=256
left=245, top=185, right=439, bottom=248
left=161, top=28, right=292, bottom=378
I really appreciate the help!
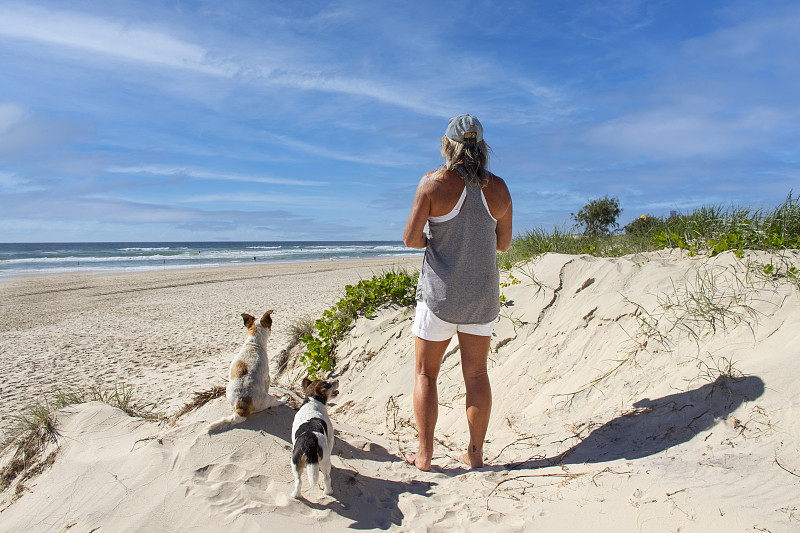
left=403, top=115, right=512, bottom=471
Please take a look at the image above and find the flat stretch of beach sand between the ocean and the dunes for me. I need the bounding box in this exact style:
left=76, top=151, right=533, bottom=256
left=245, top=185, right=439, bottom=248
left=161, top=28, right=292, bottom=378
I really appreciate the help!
left=0, top=258, right=421, bottom=426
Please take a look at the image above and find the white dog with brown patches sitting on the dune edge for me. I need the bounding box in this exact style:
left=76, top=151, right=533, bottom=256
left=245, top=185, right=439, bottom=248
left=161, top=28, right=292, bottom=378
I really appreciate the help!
left=207, top=309, right=285, bottom=433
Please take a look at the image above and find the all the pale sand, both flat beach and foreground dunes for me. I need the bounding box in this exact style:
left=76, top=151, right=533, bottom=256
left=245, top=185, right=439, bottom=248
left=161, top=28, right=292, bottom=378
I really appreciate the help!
left=0, top=251, right=800, bottom=532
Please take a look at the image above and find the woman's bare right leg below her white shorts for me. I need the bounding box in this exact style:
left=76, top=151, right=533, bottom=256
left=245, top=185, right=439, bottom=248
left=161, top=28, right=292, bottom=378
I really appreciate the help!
left=458, top=332, right=492, bottom=468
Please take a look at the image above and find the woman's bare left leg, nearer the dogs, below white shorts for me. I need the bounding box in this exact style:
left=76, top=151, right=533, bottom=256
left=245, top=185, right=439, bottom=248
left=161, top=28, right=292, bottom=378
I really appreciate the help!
left=406, top=336, right=450, bottom=471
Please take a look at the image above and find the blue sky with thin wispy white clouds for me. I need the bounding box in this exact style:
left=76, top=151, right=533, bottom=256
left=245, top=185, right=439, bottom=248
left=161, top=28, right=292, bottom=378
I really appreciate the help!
left=0, top=0, right=800, bottom=242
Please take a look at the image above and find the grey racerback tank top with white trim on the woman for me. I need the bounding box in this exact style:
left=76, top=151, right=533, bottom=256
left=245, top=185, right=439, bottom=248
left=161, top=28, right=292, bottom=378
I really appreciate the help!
left=417, top=167, right=500, bottom=324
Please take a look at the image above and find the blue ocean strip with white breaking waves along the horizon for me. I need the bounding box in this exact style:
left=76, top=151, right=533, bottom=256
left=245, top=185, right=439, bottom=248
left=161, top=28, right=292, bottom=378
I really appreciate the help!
left=0, top=241, right=420, bottom=279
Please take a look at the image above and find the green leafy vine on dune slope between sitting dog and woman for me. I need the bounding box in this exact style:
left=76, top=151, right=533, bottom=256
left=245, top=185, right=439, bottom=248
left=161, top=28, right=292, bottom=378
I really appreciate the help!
left=300, top=270, right=418, bottom=378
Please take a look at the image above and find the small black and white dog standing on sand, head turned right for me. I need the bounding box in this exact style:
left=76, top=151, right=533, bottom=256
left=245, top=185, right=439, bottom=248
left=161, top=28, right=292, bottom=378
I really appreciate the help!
left=292, top=378, right=339, bottom=498
